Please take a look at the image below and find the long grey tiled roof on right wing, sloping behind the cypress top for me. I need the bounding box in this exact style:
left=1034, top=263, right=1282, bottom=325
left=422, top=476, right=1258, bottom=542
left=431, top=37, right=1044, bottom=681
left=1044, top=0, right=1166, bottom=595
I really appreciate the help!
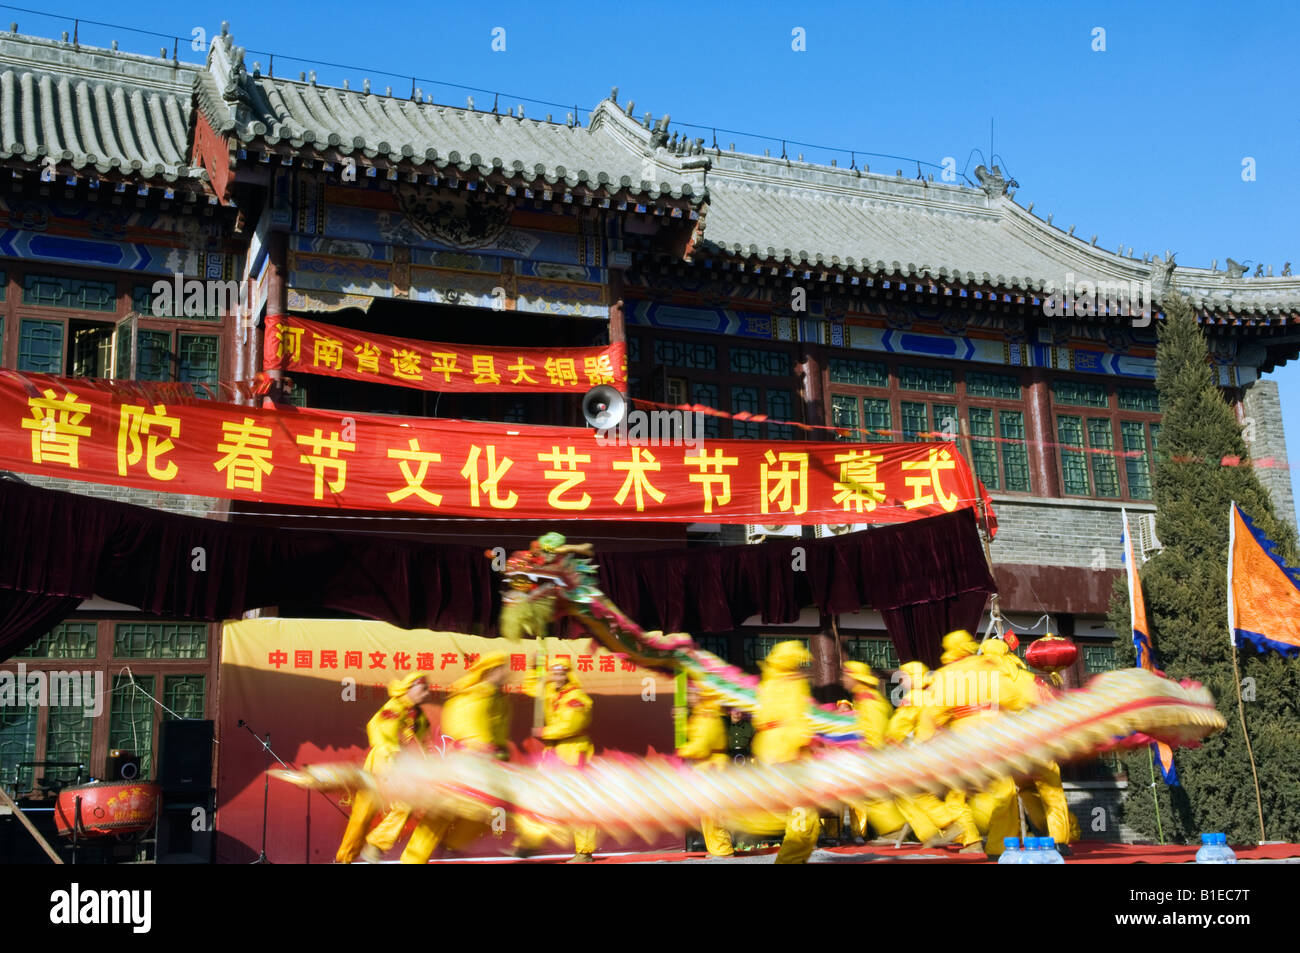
left=697, top=150, right=1300, bottom=317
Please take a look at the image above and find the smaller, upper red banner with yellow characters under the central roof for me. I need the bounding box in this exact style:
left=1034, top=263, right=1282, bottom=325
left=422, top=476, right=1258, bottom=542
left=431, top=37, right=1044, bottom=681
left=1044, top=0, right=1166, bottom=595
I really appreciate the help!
left=263, top=315, right=628, bottom=394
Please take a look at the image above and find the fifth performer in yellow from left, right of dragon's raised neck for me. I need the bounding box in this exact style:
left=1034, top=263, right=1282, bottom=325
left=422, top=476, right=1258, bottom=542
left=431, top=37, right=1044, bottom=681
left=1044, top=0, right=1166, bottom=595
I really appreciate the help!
left=735, top=640, right=822, bottom=863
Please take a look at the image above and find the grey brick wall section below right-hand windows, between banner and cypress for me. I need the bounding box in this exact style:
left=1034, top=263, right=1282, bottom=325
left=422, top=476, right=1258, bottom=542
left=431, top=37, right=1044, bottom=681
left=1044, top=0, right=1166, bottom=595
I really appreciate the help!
left=989, top=494, right=1156, bottom=569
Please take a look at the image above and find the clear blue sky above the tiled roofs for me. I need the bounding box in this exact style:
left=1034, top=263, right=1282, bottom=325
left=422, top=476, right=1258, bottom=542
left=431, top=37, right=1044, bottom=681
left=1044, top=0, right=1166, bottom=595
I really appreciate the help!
left=12, top=0, right=1300, bottom=520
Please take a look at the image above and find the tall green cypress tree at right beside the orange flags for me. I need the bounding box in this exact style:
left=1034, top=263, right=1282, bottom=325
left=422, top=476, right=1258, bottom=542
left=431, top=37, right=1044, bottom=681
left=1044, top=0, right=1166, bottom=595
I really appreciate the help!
left=1110, top=298, right=1300, bottom=844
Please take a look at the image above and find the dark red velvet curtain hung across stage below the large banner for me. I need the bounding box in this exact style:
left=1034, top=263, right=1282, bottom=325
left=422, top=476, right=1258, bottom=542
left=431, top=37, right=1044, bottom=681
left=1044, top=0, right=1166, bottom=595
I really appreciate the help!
left=0, top=481, right=995, bottom=663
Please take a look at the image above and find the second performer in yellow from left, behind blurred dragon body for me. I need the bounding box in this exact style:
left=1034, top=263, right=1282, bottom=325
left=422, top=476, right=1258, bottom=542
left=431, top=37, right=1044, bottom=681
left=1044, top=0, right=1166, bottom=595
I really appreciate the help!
left=402, top=651, right=510, bottom=863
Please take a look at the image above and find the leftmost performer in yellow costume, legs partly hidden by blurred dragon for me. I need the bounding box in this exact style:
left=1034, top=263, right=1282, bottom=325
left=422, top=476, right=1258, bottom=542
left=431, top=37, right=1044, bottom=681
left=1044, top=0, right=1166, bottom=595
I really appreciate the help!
left=334, top=673, right=432, bottom=863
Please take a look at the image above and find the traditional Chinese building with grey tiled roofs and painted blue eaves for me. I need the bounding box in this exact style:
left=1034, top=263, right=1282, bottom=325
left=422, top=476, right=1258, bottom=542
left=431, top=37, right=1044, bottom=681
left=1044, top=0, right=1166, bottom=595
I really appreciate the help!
left=0, top=22, right=1300, bottom=836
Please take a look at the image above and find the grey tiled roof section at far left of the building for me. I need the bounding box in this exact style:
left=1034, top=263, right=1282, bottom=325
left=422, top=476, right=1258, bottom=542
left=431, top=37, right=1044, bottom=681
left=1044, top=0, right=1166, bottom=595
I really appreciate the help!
left=0, top=34, right=205, bottom=183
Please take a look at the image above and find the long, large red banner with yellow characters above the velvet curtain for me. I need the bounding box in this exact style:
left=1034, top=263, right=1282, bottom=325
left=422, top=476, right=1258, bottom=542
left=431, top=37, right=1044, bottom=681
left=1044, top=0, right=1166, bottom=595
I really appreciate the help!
left=0, top=371, right=978, bottom=525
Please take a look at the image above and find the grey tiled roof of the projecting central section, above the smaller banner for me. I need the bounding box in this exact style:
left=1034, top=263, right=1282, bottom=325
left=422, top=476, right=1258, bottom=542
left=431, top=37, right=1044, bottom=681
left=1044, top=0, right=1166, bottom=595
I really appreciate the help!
left=199, top=35, right=707, bottom=202
